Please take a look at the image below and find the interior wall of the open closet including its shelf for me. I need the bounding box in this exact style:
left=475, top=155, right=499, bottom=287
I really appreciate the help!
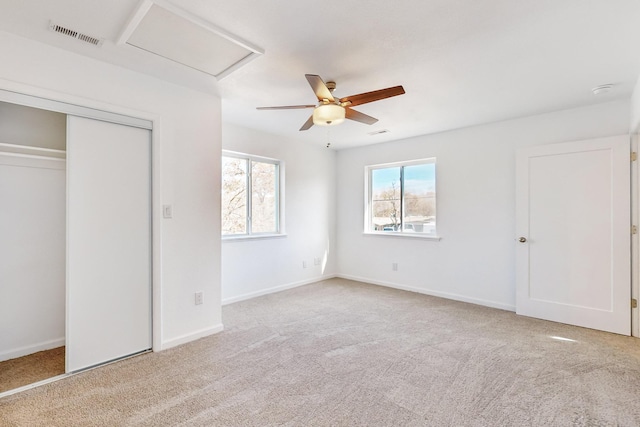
left=0, top=102, right=66, bottom=361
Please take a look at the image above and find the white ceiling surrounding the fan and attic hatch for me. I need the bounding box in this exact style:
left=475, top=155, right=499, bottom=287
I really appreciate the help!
left=0, top=0, right=640, bottom=149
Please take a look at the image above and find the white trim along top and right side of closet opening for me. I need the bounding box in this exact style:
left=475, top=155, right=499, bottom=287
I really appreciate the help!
left=0, top=79, right=162, bottom=351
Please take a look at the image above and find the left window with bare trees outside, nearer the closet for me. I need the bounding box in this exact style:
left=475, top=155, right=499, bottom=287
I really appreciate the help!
left=221, top=152, right=281, bottom=237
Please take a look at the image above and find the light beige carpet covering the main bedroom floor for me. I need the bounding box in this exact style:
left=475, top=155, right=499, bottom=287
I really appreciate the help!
left=0, top=279, right=640, bottom=426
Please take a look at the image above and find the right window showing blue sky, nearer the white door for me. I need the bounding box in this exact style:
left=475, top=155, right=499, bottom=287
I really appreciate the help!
left=365, top=158, right=436, bottom=237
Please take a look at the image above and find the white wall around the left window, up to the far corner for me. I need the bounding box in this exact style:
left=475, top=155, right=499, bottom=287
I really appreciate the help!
left=222, top=123, right=336, bottom=303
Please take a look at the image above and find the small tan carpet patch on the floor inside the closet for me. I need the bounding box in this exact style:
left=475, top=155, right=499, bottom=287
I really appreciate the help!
left=0, top=347, right=64, bottom=393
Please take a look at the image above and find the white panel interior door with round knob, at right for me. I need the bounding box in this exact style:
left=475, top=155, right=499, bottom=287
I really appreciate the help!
left=516, top=136, right=631, bottom=335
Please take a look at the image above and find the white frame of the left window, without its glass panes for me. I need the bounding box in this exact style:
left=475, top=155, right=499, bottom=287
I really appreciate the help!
left=220, top=150, right=286, bottom=240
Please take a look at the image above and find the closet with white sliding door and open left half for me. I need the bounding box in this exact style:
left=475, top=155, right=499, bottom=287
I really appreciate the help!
left=0, top=91, right=152, bottom=393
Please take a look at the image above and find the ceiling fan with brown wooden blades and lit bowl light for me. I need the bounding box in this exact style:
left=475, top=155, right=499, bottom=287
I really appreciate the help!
left=257, top=74, right=405, bottom=130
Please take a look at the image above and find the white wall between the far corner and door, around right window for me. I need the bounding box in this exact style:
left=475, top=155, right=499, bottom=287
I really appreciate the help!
left=337, top=101, right=630, bottom=310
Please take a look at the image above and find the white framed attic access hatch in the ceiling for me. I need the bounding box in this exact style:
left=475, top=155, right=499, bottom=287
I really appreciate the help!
left=118, top=0, right=264, bottom=80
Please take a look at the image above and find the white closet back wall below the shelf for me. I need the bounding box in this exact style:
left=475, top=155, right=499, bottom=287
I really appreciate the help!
left=0, top=152, right=66, bottom=361
